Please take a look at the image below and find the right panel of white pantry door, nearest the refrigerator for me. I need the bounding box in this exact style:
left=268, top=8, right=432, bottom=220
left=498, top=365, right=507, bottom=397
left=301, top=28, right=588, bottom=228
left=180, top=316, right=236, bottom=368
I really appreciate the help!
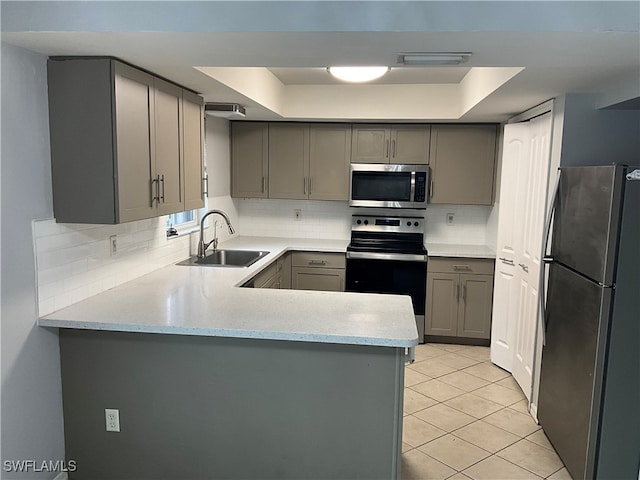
left=511, top=113, right=551, bottom=400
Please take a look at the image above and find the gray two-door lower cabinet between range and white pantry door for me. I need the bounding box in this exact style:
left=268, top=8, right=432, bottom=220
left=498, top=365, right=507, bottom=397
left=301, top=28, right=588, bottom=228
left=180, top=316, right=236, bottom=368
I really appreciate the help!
left=425, top=257, right=494, bottom=339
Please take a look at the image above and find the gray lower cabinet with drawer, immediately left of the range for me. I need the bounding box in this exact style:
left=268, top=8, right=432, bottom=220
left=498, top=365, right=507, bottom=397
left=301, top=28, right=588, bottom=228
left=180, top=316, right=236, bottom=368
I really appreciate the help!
left=291, top=252, right=345, bottom=292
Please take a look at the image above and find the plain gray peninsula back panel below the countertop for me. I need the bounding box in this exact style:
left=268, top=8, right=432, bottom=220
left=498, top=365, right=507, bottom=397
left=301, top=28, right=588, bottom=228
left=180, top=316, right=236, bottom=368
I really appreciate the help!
left=60, top=330, right=405, bottom=480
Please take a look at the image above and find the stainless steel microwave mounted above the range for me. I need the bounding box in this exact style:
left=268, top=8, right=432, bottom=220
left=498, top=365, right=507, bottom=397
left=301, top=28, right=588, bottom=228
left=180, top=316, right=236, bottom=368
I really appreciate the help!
left=349, top=163, right=429, bottom=209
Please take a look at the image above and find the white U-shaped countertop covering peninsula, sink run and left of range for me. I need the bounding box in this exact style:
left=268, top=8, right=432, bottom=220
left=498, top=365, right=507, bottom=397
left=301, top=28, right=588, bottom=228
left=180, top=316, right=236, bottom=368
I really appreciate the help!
left=38, top=237, right=418, bottom=347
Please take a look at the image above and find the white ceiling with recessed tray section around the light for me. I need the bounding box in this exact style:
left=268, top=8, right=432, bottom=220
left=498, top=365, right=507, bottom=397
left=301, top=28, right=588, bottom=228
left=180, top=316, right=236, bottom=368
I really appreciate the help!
left=0, top=1, right=640, bottom=121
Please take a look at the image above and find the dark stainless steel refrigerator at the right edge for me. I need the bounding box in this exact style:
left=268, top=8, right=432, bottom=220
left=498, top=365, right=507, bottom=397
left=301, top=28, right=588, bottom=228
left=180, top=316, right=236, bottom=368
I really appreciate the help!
left=538, top=165, right=640, bottom=480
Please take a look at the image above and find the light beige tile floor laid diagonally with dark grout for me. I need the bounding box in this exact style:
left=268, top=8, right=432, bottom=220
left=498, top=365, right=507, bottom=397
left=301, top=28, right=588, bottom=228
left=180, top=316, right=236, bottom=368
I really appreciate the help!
left=402, top=343, right=571, bottom=480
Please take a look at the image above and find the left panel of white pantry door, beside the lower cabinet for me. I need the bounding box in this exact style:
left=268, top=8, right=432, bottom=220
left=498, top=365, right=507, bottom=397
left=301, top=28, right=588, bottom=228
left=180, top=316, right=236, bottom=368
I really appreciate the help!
left=491, top=122, right=530, bottom=372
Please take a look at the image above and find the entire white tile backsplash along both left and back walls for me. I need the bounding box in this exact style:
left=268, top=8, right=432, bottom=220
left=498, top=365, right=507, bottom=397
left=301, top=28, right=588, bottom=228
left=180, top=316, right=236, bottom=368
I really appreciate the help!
left=33, top=196, right=495, bottom=316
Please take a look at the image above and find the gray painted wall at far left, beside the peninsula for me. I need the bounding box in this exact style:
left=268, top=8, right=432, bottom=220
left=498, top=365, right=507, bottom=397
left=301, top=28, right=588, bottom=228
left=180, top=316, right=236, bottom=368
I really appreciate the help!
left=0, top=43, right=64, bottom=479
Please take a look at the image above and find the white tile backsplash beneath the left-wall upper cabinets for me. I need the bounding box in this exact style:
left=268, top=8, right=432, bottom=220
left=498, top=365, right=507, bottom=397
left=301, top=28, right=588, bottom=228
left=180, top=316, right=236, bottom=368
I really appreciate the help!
left=33, top=217, right=190, bottom=316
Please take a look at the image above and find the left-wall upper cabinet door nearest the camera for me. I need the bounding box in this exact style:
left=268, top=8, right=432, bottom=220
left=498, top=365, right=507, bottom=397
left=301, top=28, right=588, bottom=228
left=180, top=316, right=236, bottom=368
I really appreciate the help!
left=114, top=62, right=157, bottom=223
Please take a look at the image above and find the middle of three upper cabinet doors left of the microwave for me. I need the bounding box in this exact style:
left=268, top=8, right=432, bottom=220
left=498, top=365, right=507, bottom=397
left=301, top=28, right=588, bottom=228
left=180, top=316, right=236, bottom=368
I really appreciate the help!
left=269, top=123, right=309, bottom=199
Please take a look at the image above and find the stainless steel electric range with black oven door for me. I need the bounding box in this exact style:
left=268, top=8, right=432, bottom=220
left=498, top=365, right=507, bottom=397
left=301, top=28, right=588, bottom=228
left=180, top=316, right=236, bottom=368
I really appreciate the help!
left=346, top=215, right=427, bottom=343
